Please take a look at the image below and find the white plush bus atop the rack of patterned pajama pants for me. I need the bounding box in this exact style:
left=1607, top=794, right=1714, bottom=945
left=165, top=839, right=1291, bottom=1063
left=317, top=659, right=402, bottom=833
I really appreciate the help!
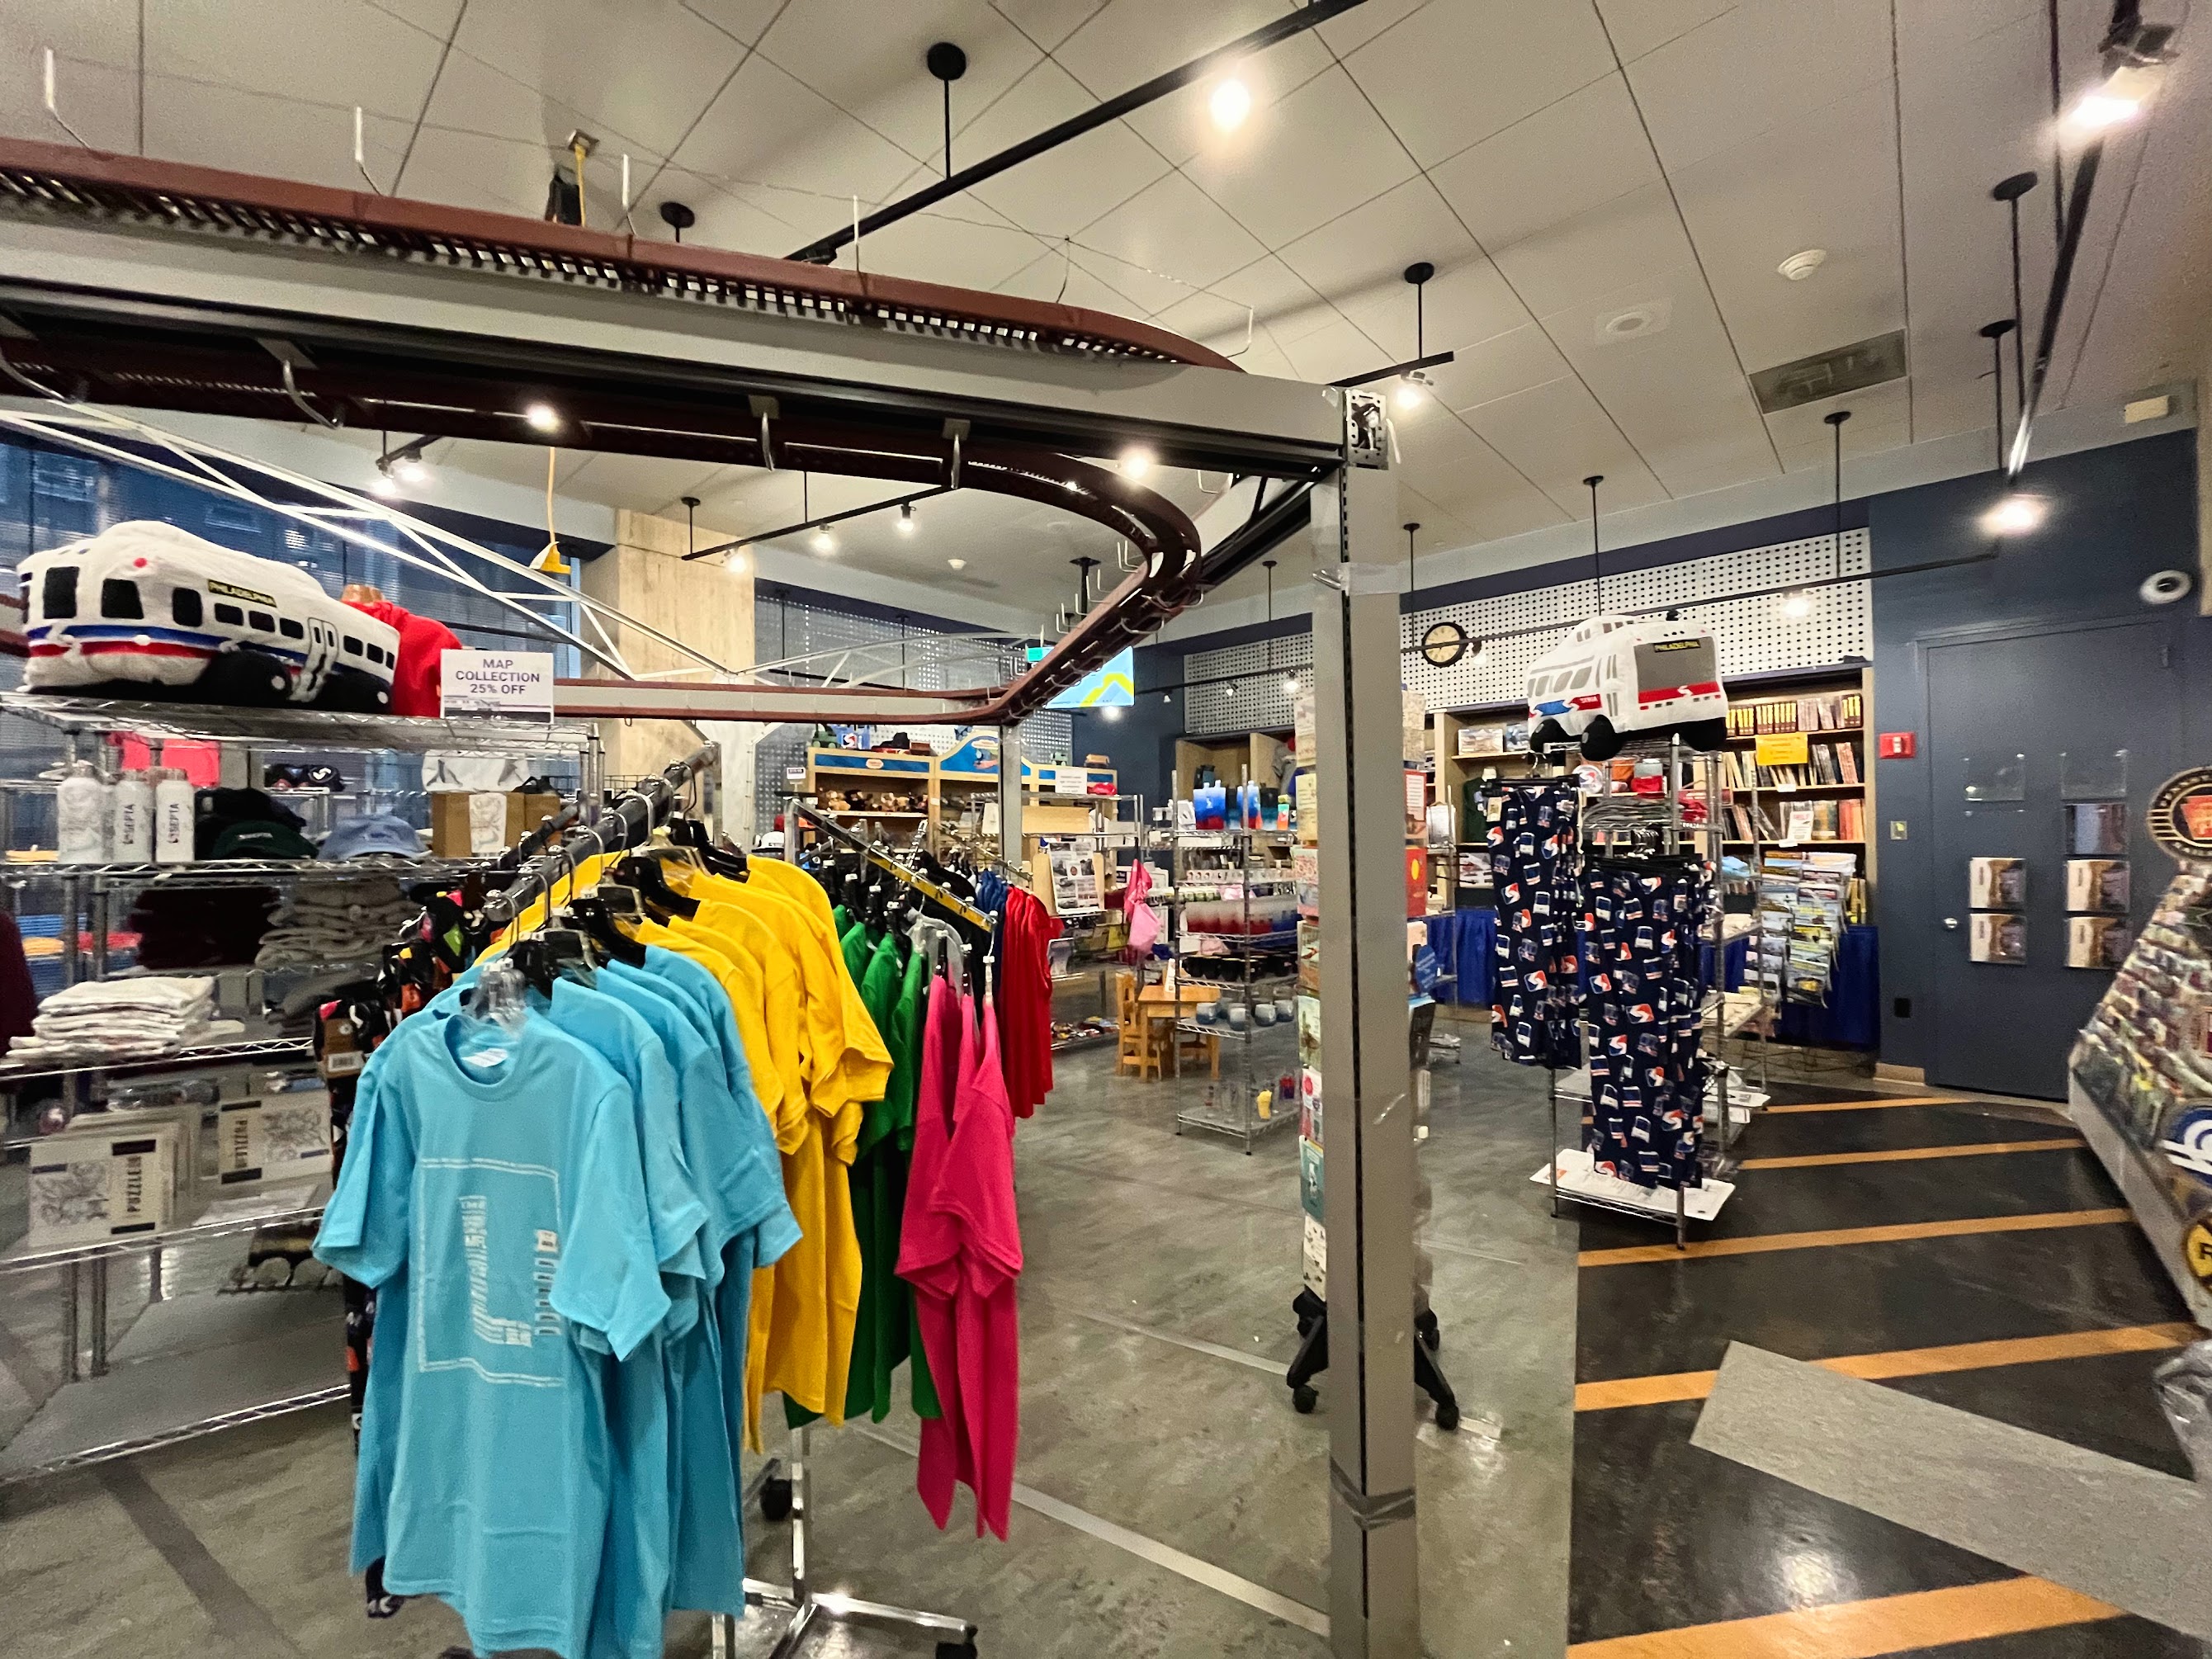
left=1529, top=615, right=1728, bottom=761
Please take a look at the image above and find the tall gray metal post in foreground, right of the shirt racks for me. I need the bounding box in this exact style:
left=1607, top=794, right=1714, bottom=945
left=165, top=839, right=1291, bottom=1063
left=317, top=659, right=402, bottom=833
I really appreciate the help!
left=1314, top=391, right=1420, bottom=1659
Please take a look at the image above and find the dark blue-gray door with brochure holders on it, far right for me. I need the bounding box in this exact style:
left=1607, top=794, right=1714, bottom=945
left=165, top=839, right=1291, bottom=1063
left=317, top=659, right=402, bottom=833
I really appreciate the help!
left=1925, top=622, right=2181, bottom=1099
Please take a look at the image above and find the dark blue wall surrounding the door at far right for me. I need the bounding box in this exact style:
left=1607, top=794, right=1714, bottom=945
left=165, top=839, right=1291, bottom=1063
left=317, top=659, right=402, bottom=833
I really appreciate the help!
left=1869, top=432, right=2212, bottom=1066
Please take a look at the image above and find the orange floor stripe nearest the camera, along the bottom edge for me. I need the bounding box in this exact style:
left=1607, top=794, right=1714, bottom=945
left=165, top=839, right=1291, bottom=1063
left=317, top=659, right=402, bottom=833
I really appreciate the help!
left=1566, top=1577, right=2119, bottom=1659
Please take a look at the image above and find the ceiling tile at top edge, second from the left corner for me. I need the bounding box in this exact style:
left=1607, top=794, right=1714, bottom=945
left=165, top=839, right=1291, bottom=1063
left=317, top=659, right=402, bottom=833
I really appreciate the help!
left=146, top=0, right=440, bottom=122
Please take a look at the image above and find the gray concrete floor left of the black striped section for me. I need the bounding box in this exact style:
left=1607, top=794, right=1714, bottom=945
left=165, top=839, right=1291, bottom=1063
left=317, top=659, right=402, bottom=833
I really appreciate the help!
left=0, top=1024, right=1577, bottom=1659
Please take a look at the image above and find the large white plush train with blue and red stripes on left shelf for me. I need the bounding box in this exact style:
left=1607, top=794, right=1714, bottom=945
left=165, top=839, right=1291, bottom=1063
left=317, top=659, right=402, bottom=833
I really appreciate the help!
left=20, top=520, right=400, bottom=715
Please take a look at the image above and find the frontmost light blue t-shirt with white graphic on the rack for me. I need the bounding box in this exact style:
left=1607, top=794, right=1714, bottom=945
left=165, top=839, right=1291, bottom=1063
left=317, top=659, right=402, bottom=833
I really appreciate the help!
left=316, top=1013, right=668, bottom=1659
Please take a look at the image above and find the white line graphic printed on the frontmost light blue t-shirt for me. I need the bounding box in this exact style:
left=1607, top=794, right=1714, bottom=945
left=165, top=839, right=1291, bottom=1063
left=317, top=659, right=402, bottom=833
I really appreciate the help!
left=411, top=1157, right=569, bottom=1389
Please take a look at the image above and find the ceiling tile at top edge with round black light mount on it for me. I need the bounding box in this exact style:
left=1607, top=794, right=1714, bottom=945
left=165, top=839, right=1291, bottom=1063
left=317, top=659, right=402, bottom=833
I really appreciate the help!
left=759, top=0, right=1042, bottom=170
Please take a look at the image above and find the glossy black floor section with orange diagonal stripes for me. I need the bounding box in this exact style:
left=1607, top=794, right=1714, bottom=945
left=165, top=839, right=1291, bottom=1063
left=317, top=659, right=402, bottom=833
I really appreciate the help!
left=1571, top=1086, right=2212, bottom=1659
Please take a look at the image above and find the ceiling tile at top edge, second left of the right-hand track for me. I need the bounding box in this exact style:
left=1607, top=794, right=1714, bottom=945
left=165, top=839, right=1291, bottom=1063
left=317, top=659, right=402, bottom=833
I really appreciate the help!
left=1628, top=0, right=1891, bottom=173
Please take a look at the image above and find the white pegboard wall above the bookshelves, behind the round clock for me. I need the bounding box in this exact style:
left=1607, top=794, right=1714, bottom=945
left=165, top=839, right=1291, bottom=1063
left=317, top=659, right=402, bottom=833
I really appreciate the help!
left=1184, top=529, right=1874, bottom=736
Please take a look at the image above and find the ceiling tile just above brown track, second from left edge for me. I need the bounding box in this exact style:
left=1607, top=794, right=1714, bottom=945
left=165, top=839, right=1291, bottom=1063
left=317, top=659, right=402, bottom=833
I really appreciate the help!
left=146, top=75, right=415, bottom=206
